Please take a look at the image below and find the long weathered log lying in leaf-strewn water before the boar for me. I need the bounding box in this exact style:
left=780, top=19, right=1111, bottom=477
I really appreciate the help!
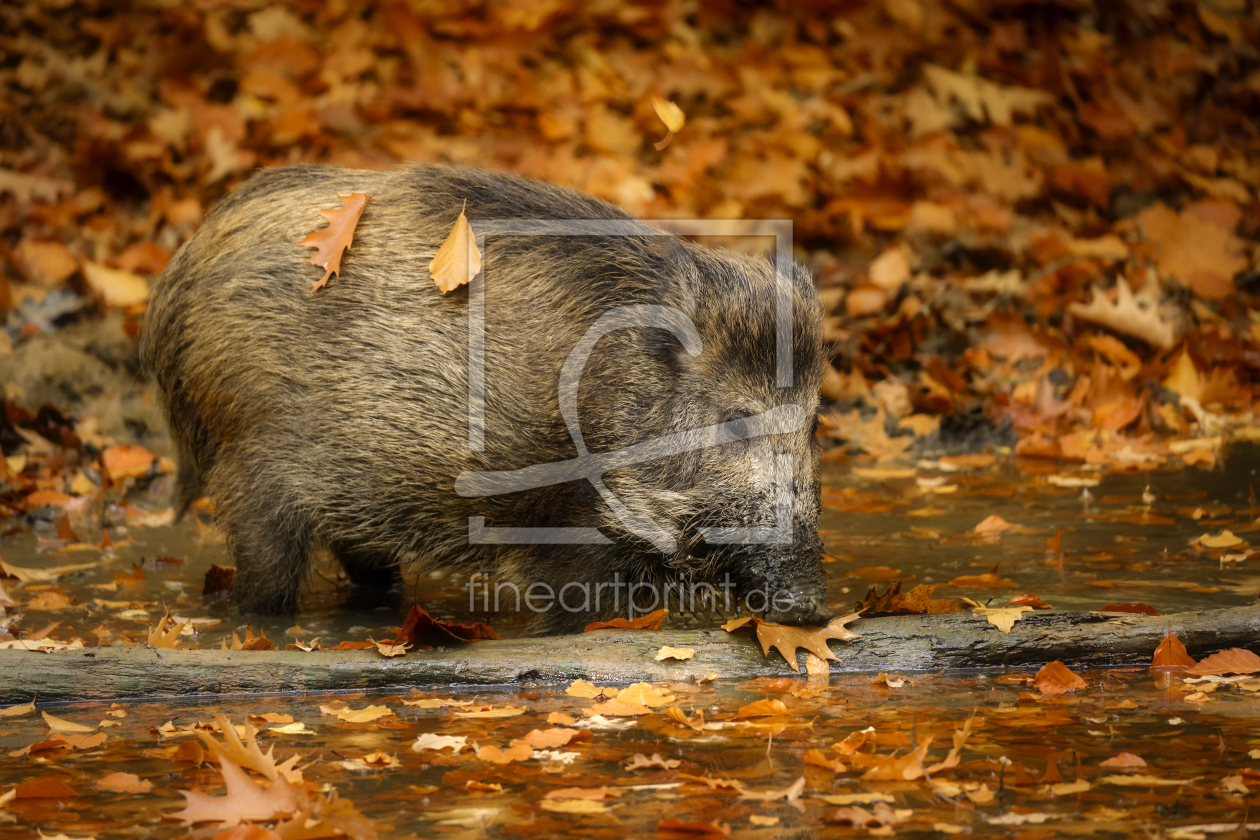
left=0, top=607, right=1260, bottom=704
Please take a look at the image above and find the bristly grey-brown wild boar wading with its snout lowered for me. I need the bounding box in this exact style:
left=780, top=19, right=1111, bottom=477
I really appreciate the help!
left=141, top=166, right=825, bottom=631
